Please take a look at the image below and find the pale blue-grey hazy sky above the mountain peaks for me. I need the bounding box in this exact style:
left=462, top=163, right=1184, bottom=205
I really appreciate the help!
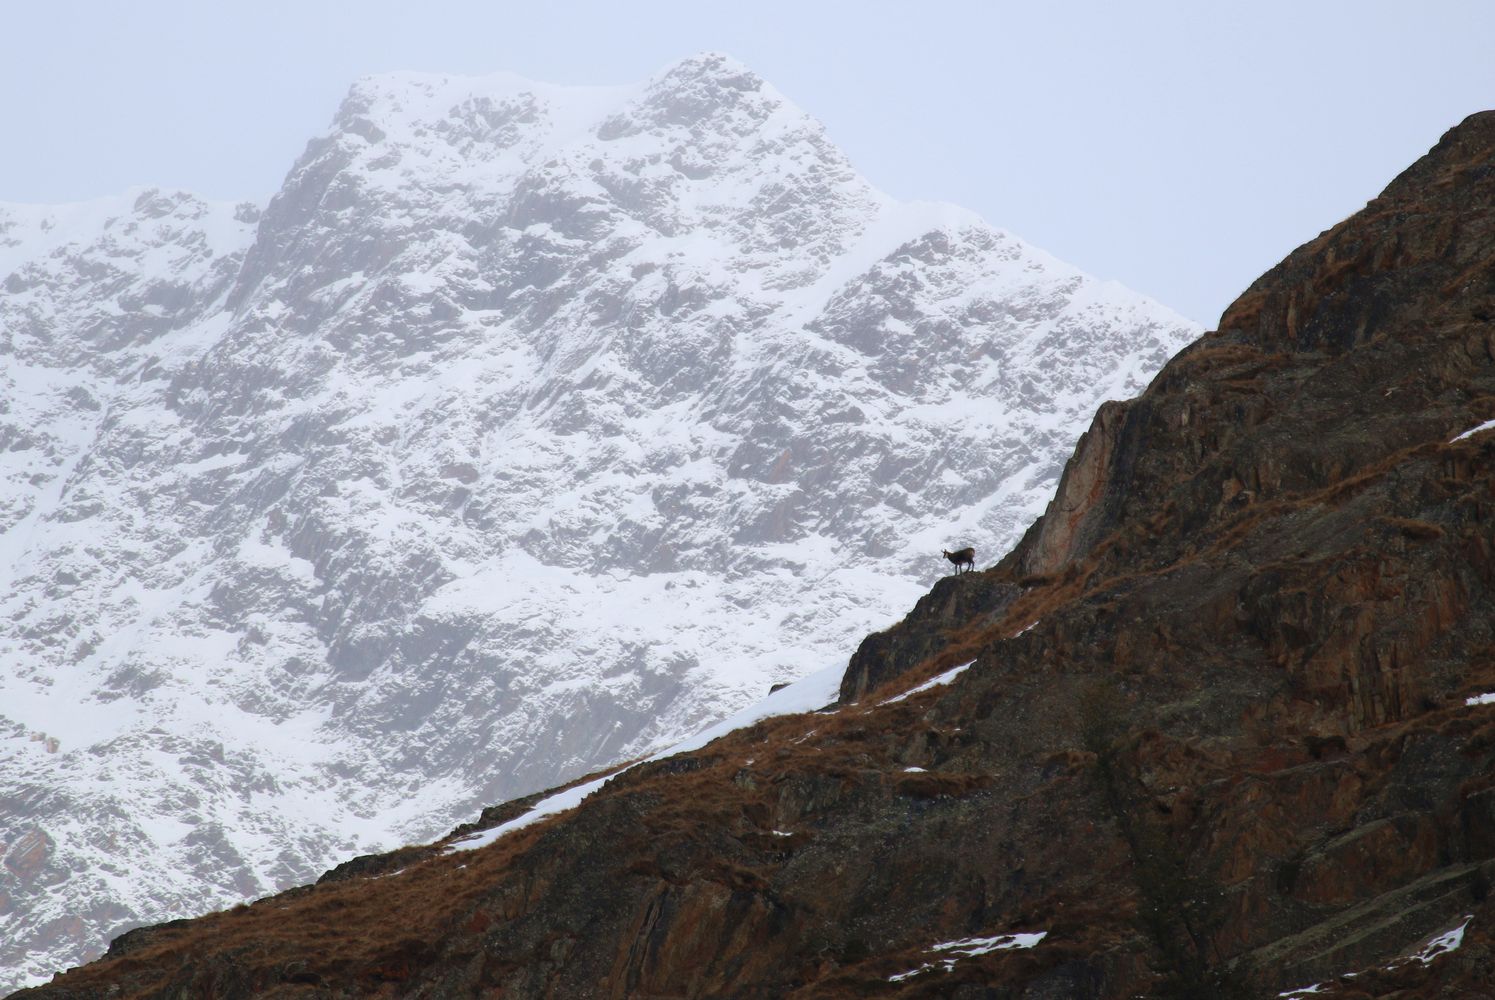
left=0, top=0, right=1495, bottom=326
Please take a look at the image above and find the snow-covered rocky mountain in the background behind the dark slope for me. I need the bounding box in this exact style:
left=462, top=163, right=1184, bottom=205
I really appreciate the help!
left=0, top=55, right=1197, bottom=987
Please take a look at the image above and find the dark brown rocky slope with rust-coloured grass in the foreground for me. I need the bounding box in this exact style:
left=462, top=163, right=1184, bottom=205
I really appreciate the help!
left=14, top=114, right=1495, bottom=999
